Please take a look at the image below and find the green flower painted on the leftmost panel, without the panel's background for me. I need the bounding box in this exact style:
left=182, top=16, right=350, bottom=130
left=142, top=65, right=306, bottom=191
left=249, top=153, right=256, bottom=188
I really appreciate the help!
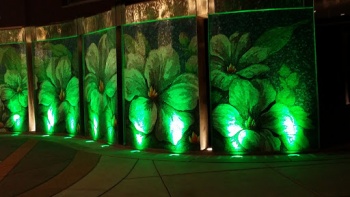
left=0, top=46, right=28, bottom=132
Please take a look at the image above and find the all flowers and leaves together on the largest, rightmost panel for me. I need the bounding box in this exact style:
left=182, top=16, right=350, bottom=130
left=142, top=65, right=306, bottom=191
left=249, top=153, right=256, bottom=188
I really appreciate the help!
left=210, top=16, right=313, bottom=152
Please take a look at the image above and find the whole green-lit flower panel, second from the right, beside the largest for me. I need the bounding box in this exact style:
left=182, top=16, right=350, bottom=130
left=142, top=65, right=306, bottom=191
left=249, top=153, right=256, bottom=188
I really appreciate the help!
left=123, top=17, right=199, bottom=152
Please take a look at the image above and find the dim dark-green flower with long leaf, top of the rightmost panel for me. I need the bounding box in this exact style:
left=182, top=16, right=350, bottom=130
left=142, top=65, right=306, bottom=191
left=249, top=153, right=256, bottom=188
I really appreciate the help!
left=210, top=22, right=304, bottom=91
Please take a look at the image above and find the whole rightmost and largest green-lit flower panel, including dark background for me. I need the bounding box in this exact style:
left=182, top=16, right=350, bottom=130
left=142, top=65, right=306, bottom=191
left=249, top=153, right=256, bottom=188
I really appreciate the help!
left=209, top=9, right=318, bottom=153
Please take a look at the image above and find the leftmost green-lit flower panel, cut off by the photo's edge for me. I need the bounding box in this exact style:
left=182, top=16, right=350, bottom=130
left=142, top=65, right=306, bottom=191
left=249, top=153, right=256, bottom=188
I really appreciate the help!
left=0, top=44, right=28, bottom=133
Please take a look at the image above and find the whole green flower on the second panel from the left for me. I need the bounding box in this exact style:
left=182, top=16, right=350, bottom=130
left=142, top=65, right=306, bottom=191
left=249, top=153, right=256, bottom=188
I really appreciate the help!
left=38, top=56, right=79, bottom=135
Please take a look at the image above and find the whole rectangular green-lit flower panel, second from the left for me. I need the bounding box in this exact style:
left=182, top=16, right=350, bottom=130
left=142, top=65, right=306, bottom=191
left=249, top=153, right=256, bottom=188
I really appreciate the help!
left=34, top=38, right=80, bottom=136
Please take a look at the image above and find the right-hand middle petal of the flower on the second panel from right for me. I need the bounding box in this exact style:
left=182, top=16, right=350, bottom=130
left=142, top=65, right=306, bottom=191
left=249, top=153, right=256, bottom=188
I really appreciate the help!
left=161, top=81, right=198, bottom=111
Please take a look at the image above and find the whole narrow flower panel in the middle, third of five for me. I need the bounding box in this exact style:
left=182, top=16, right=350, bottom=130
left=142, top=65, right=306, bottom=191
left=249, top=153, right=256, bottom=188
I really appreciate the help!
left=83, top=27, right=118, bottom=144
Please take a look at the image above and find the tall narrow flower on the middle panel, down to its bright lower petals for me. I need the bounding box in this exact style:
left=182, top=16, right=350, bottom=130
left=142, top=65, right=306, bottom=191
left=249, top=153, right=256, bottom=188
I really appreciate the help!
left=84, top=33, right=117, bottom=143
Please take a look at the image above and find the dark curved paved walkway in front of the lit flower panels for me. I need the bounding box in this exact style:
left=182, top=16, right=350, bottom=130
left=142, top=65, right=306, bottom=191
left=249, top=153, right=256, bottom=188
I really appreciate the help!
left=0, top=134, right=350, bottom=197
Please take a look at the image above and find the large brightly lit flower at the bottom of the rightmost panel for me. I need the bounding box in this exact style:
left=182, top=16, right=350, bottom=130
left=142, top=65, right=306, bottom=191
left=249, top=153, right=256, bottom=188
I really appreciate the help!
left=213, top=78, right=308, bottom=152
